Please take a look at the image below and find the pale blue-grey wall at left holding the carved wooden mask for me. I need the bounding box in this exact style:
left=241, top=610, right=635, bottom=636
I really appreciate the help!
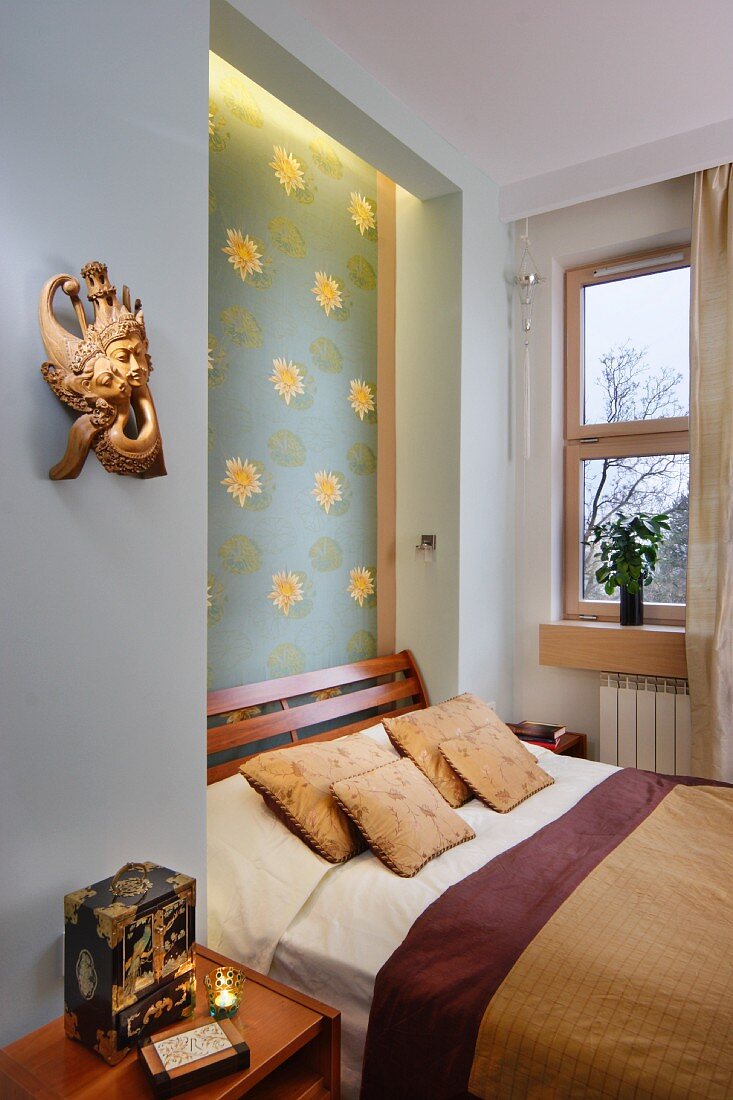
left=0, top=0, right=208, bottom=1044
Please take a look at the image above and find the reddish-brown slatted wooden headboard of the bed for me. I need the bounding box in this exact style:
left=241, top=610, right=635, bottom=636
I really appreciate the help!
left=207, top=649, right=429, bottom=783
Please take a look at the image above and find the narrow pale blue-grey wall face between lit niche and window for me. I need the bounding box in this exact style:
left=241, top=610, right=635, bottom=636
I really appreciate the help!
left=457, top=177, right=517, bottom=719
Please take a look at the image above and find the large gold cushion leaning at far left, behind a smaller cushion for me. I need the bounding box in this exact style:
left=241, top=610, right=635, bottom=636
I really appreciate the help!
left=239, top=735, right=394, bottom=864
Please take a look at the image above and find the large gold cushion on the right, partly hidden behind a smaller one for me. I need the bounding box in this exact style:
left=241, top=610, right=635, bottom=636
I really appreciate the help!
left=382, top=692, right=506, bottom=806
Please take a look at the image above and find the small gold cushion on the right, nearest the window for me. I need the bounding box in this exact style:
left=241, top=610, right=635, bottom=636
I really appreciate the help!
left=440, top=723, right=555, bottom=814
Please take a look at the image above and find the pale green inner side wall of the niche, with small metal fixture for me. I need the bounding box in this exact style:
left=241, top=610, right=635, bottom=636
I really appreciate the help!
left=395, top=187, right=461, bottom=702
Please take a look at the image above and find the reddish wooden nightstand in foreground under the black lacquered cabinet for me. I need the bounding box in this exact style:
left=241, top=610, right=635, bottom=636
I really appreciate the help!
left=0, top=946, right=341, bottom=1100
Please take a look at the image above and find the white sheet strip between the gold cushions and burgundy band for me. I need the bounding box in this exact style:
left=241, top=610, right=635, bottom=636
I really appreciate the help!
left=270, top=746, right=619, bottom=1100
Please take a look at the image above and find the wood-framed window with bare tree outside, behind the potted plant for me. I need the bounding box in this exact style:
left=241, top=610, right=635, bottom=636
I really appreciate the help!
left=565, top=248, right=690, bottom=624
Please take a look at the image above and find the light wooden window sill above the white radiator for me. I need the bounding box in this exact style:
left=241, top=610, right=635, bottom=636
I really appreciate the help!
left=539, top=619, right=687, bottom=680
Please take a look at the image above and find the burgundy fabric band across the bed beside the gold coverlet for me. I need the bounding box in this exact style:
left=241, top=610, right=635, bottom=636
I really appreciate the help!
left=361, top=769, right=724, bottom=1100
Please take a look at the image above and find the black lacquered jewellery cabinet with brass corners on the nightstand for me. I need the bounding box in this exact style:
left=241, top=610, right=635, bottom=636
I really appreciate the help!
left=64, top=864, right=196, bottom=1065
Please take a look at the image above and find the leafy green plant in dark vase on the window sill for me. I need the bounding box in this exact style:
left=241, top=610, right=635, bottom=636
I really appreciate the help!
left=588, top=512, right=669, bottom=626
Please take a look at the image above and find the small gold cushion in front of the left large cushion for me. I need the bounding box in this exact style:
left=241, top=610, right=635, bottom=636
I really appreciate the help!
left=325, top=759, right=475, bottom=879
